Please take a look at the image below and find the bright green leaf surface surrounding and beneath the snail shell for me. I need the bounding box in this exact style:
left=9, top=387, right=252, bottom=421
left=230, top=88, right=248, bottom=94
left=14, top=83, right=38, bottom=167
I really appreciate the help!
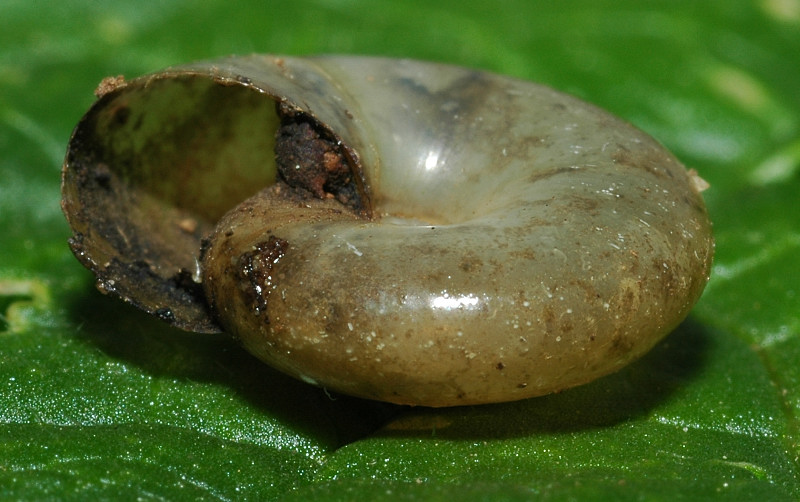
left=0, top=0, right=800, bottom=501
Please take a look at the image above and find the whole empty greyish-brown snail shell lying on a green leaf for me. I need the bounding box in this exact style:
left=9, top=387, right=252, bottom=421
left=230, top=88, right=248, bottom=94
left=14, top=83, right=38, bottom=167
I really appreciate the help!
left=62, top=55, right=714, bottom=406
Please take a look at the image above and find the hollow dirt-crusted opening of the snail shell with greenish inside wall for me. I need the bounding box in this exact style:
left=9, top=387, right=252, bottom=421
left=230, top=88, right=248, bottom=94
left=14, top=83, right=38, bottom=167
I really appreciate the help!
left=62, top=72, right=356, bottom=332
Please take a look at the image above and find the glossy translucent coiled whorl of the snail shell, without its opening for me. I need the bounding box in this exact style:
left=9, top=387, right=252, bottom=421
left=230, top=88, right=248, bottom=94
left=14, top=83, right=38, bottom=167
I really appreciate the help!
left=198, top=59, right=712, bottom=406
